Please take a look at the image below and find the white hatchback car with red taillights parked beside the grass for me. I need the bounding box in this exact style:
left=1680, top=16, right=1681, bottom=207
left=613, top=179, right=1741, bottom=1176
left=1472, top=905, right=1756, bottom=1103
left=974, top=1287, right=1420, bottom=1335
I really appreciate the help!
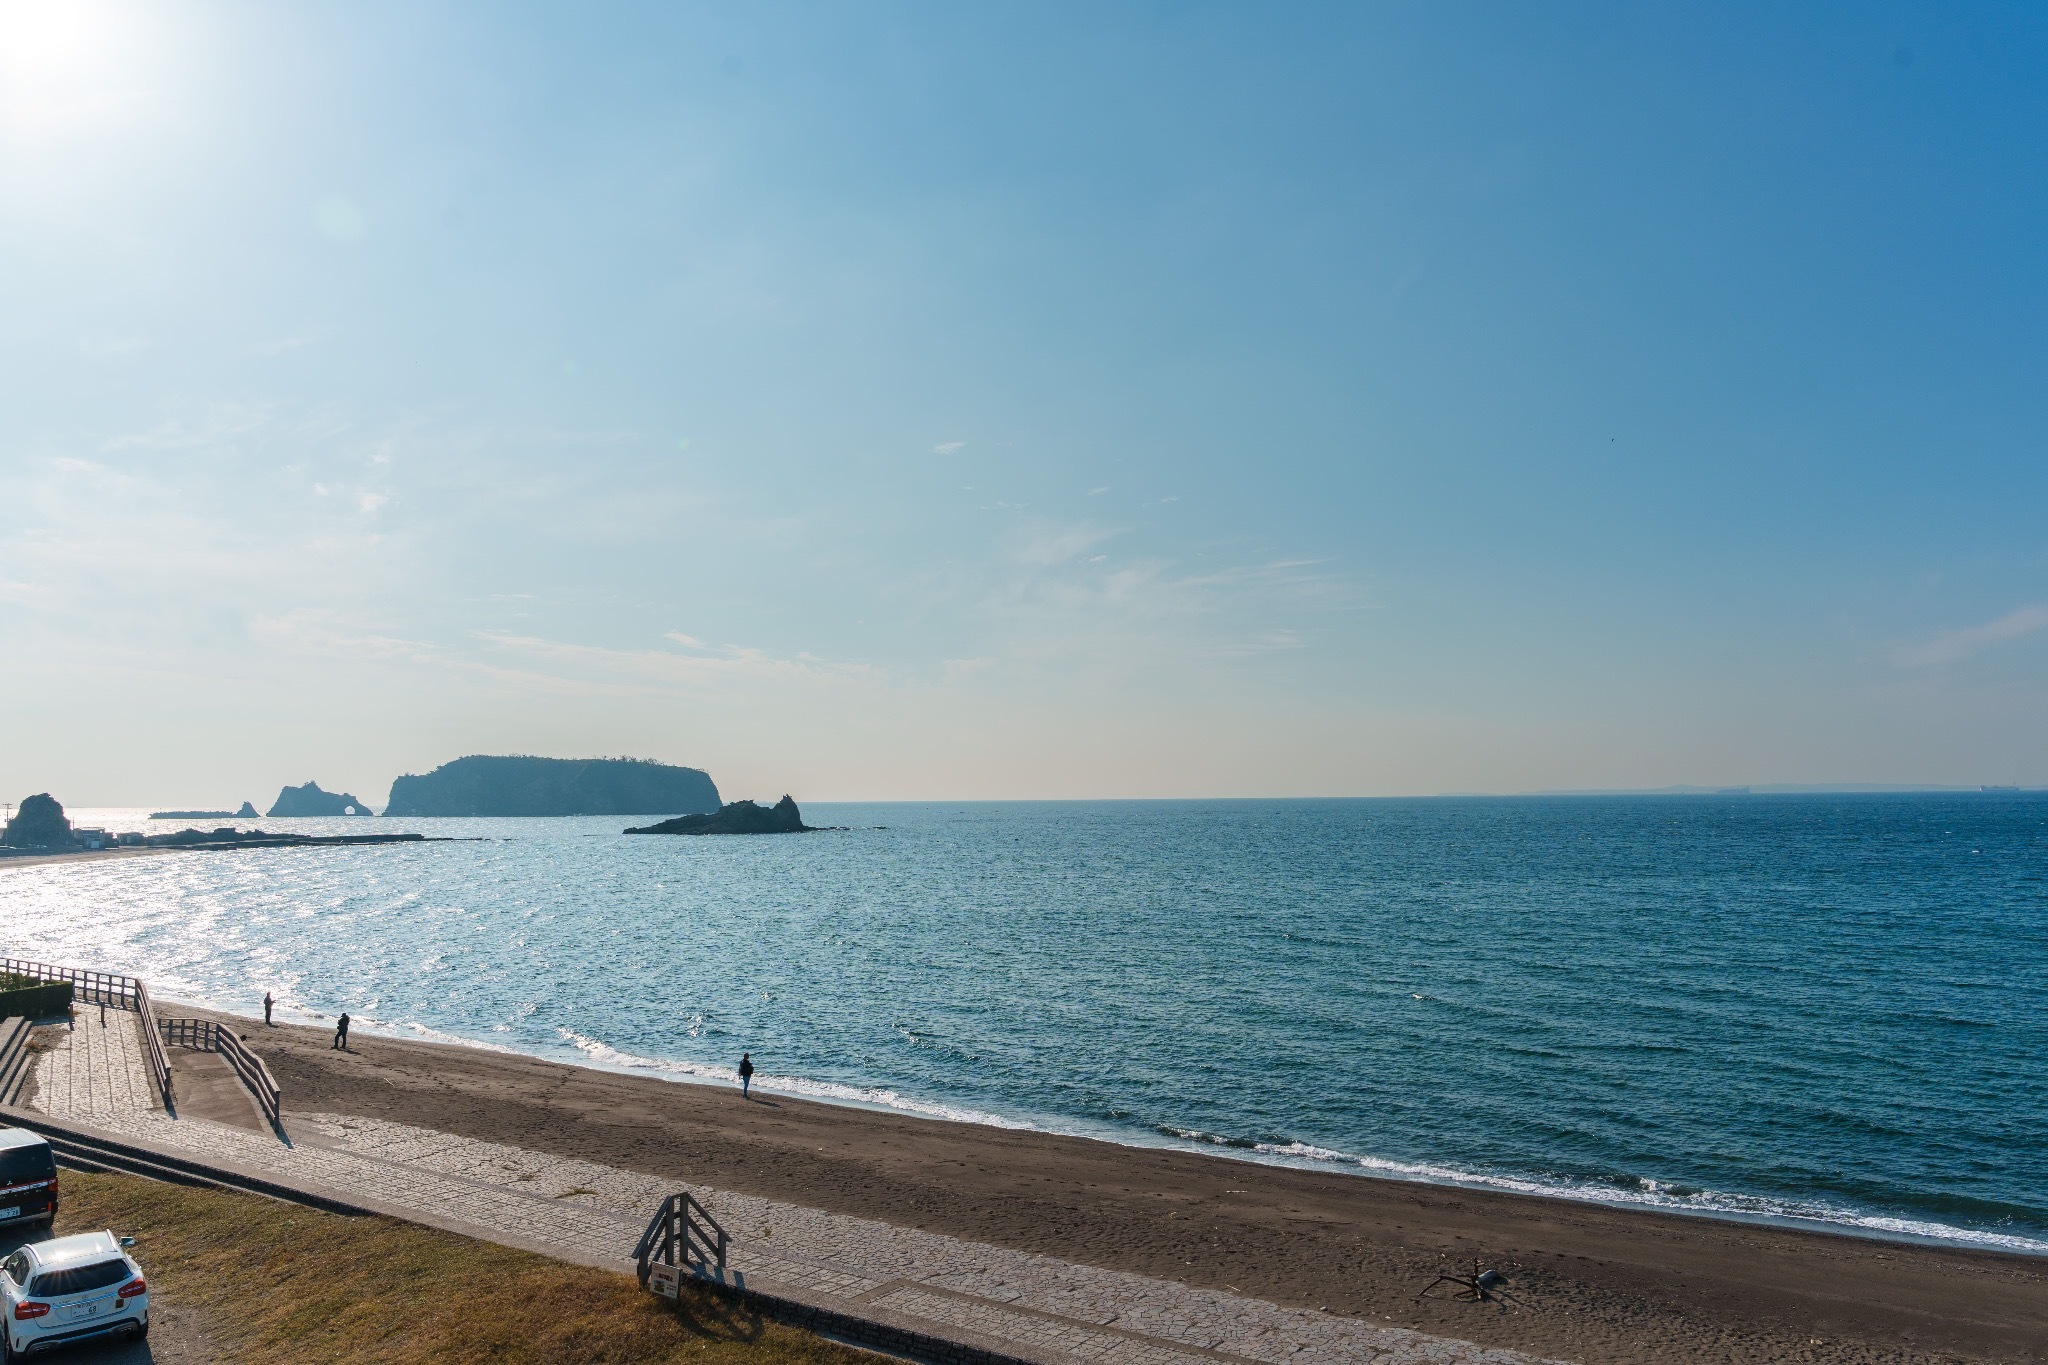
left=0, top=1232, right=150, bottom=1361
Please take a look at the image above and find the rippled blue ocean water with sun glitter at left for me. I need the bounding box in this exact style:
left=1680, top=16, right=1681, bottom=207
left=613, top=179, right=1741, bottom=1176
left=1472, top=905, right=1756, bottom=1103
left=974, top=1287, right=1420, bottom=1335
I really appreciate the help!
left=0, top=792, right=2048, bottom=1252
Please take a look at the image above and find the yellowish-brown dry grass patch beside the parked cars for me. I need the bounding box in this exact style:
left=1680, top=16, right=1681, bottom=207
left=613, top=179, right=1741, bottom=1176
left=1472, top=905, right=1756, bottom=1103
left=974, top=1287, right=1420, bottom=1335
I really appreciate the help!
left=57, top=1171, right=874, bottom=1365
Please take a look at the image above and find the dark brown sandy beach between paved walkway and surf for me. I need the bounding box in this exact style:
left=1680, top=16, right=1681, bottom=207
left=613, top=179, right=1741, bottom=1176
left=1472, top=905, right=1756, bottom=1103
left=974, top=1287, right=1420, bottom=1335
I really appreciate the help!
left=176, top=1021, right=2048, bottom=1365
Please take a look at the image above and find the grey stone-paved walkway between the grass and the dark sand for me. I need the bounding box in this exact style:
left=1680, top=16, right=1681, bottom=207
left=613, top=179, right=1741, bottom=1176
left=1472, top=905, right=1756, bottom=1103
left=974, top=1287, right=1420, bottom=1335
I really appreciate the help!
left=19, top=1011, right=1564, bottom=1365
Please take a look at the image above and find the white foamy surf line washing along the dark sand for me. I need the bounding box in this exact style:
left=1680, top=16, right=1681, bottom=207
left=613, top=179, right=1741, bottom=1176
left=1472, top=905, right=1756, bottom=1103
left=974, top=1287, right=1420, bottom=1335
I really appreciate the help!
left=184, top=999, right=2048, bottom=1261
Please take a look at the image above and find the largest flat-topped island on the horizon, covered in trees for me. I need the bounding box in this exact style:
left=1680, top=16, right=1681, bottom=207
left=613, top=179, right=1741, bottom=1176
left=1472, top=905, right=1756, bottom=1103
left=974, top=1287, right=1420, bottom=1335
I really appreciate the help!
left=385, top=753, right=719, bottom=814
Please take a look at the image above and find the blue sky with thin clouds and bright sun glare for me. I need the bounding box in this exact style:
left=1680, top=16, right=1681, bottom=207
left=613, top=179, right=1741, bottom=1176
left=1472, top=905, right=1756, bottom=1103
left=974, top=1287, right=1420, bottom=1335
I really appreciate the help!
left=0, top=0, right=2048, bottom=804
